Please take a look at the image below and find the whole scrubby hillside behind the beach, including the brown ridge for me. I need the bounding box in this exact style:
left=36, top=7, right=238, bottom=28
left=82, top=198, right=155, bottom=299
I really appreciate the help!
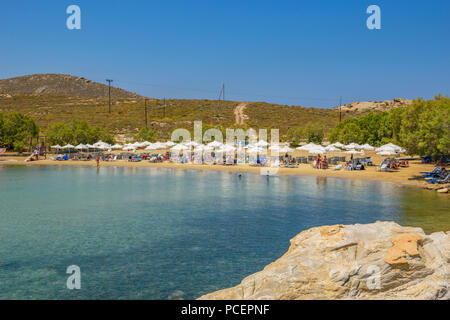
left=0, top=74, right=414, bottom=139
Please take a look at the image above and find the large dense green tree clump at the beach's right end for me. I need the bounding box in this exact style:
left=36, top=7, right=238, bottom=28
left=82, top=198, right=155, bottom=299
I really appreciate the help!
left=328, top=95, right=450, bottom=157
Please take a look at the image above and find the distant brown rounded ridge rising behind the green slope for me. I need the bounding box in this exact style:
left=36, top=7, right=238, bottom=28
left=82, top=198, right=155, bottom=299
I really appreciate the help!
left=0, top=74, right=140, bottom=98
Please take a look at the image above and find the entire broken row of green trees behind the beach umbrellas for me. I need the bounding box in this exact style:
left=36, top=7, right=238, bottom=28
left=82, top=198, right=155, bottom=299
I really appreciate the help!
left=0, top=95, right=450, bottom=157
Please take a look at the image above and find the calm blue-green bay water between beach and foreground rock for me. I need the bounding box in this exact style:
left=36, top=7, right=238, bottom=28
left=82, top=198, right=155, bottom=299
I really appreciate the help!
left=0, top=167, right=450, bottom=299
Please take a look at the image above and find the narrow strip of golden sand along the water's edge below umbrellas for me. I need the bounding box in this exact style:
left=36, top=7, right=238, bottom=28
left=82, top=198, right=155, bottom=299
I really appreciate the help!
left=0, top=157, right=445, bottom=188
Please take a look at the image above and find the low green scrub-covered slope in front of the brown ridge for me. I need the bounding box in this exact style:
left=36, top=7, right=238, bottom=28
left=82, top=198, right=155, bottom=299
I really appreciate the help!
left=0, top=93, right=339, bottom=139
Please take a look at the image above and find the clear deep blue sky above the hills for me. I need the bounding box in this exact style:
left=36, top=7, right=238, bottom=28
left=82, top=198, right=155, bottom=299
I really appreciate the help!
left=0, top=0, right=450, bottom=107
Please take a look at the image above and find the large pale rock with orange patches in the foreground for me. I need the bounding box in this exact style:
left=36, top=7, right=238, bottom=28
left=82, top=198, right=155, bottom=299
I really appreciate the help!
left=200, top=222, right=450, bottom=300
